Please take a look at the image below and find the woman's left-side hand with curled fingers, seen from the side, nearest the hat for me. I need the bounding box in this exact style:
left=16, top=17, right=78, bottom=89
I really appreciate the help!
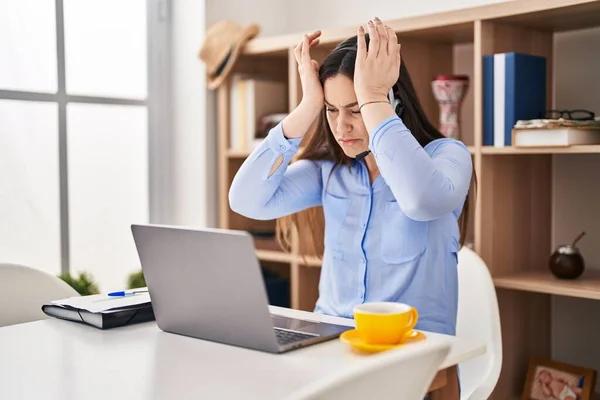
left=294, top=30, right=324, bottom=110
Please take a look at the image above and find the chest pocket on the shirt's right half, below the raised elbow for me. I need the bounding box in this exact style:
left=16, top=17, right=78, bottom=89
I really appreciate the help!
left=381, top=200, right=429, bottom=264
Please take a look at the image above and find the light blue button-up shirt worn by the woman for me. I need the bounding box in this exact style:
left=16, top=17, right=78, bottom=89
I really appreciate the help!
left=229, top=116, right=472, bottom=335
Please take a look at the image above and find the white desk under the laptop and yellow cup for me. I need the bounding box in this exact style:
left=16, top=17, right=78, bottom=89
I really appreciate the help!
left=0, top=307, right=485, bottom=400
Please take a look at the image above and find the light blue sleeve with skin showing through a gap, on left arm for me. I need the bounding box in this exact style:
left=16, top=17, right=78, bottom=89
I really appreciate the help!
left=229, top=123, right=322, bottom=220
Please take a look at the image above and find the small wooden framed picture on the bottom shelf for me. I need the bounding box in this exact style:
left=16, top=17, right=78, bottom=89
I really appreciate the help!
left=521, top=358, right=596, bottom=400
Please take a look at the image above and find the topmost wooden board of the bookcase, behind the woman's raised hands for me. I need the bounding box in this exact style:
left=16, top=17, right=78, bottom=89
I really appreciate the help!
left=243, top=0, right=600, bottom=55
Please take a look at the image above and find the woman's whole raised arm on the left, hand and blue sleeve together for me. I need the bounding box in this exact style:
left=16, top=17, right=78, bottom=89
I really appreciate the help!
left=229, top=31, right=323, bottom=219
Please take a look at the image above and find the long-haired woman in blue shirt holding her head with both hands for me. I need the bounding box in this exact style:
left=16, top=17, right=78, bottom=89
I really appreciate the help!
left=229, top=19, right=473, bottom=334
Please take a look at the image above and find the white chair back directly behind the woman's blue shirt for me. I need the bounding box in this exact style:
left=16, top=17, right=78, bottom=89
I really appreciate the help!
left=456, top=247, right=502, bottom=400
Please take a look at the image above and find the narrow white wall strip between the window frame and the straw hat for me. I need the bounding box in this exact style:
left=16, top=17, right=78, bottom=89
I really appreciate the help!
left=170, top=0, right=210, bottom=226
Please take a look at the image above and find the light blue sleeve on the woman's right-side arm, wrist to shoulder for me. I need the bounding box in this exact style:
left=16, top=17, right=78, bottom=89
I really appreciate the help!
left=370, top=116, right=473, bottom=221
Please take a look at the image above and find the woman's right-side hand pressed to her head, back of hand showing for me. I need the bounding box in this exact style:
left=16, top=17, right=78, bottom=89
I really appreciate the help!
left=354, top=18, right=401, bottom=105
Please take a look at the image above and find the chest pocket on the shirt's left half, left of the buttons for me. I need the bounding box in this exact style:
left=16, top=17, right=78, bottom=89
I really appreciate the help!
left=323, top=194, right=350, bottom=258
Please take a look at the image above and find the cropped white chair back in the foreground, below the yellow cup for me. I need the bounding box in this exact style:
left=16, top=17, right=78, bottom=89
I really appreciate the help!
left=285, top=343, right=450, bottom=400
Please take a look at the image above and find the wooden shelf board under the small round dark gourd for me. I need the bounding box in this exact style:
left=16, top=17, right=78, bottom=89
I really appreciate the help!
left=494, top=270, right=600, bottom=300
